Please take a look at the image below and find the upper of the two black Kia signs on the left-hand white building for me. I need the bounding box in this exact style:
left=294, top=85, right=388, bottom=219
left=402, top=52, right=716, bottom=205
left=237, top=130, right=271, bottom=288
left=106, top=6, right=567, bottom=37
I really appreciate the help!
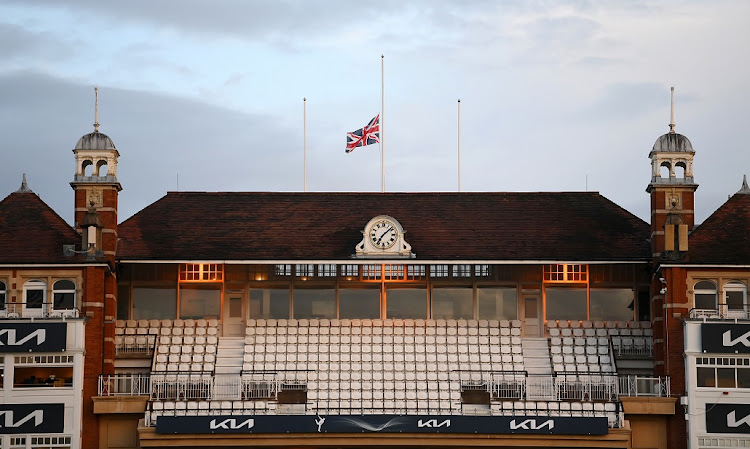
left=0, top=322, right=67, bottom=353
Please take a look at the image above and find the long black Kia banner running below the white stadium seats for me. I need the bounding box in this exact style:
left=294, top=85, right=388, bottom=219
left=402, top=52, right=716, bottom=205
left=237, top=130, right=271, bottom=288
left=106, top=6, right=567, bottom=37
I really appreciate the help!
left=156, top=415, right=608, bottom=435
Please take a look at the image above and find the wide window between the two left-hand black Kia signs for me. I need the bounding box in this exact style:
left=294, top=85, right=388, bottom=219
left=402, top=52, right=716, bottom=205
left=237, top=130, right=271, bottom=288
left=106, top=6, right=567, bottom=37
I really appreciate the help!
left=13, top=355, right=73, bottom=388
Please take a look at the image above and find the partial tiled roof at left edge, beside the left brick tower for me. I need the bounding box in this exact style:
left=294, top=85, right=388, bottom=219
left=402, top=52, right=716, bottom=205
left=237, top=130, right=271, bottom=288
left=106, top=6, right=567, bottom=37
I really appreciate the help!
left=0, top=191, right=84, bottom=264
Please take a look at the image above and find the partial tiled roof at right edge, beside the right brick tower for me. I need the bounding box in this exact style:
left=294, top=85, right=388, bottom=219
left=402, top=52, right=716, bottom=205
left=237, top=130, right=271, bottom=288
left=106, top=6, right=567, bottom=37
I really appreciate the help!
left=688, top=193, right=750, bottom=265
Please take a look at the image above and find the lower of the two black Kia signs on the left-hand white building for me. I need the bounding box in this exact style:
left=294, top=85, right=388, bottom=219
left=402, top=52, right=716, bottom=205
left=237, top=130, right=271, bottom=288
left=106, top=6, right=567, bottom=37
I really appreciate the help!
left=0, top=404, right=65, bottom=435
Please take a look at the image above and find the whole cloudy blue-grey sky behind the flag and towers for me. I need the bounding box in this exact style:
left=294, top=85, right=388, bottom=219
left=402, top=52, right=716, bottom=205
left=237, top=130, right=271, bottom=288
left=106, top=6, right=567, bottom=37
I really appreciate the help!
left=0, top=0, right=750, bottom=221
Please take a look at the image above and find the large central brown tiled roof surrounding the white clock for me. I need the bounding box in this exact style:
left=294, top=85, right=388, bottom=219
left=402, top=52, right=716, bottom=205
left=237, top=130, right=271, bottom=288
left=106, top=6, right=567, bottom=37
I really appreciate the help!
left=117, top=192, right=650, bottom=261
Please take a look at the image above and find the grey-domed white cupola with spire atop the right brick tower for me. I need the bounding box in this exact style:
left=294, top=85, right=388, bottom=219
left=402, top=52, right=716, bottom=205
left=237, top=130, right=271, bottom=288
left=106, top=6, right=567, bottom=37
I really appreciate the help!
left=646, top=87, right=695, bottom=186
